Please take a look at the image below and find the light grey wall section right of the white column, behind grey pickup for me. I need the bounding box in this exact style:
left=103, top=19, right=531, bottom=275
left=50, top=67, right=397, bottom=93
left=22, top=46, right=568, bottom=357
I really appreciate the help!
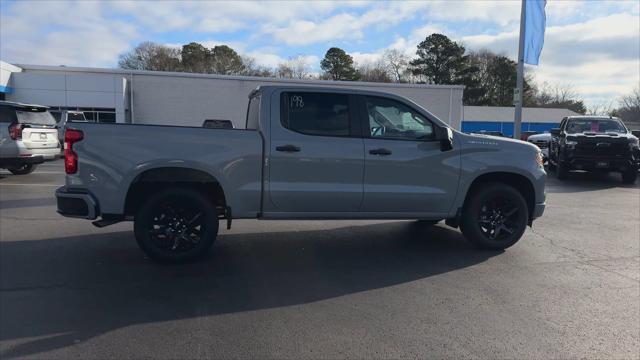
left=131, top=74, right=463, bottom=129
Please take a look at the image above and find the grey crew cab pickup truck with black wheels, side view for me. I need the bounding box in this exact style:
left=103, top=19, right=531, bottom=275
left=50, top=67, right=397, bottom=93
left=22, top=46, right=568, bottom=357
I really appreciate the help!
left=56, top=86, right=546, bottom=261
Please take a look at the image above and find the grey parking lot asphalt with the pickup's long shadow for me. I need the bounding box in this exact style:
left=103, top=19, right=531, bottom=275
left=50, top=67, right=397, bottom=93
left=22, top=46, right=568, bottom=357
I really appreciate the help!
left=0, top=162, right=640, bottom=359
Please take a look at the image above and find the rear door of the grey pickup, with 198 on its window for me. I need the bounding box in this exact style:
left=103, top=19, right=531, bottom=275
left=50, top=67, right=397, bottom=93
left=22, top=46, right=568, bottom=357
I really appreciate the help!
left=265, top=90, right=364, bottom=217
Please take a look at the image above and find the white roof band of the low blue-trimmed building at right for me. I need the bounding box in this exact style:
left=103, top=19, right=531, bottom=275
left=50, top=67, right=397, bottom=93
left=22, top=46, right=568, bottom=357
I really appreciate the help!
left=463, top=106, right=580, bottom=123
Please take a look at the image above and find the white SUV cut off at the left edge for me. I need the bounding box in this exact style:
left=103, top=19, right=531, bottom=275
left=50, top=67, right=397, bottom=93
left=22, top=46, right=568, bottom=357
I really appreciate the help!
left=0, top=101, right=60, bottom=175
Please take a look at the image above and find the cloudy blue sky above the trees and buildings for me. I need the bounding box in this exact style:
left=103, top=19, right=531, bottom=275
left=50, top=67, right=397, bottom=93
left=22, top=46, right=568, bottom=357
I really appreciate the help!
left=0, top=0, right=640, bottom=107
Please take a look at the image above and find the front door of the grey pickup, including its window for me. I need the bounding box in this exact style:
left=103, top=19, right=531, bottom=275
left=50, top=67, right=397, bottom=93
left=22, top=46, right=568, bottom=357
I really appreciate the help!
left=359, top=96, right=460, bottom=214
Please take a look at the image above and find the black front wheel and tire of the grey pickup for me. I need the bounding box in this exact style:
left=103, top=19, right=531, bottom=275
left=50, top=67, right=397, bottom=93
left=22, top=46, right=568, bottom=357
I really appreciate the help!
left=460, top=183, right=529, bottom=250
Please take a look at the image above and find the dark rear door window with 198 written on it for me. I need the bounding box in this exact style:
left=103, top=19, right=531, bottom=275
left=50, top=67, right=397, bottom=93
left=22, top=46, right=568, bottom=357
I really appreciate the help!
left=280, top=92, right=351, bottom=136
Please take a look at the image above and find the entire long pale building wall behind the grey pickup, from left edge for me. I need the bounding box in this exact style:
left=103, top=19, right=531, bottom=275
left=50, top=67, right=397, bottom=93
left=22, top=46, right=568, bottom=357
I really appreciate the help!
left=7, top=65, right=463, bottom=129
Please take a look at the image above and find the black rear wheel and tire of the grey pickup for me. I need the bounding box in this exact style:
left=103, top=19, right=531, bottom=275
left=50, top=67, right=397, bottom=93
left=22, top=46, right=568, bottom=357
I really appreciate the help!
left=134, top=188, right=219, bottom=263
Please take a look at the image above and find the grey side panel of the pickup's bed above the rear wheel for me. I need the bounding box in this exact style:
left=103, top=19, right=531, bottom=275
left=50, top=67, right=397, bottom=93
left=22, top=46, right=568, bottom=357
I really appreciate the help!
left=66, top=123, right=262, bottom=217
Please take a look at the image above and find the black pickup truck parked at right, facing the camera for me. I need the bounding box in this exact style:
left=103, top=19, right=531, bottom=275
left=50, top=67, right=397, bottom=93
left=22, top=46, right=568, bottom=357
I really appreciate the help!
left=549, top=116, right=640, bottom=183
